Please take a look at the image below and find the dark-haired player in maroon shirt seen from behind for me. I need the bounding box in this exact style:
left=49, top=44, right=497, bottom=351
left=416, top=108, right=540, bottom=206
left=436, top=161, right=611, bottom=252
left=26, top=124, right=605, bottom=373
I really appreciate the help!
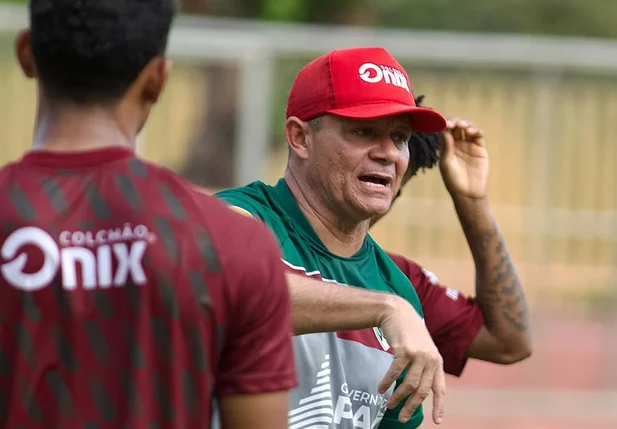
left=0, top=0, right=296, bottom=429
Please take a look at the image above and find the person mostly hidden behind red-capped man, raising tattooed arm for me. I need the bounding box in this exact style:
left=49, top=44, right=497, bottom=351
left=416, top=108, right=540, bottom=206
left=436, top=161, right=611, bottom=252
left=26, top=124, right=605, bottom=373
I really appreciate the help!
left=371, top=96, right=531, bottom=376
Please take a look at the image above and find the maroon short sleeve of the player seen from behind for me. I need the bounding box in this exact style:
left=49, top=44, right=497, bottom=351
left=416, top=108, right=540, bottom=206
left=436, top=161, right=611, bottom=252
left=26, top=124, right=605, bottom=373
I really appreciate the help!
left=217, top=221, right=297, bottom=395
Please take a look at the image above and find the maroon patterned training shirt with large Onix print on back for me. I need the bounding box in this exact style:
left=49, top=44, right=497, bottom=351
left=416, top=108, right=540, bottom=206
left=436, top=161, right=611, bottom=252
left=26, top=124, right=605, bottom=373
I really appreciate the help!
left=0, top=148, right=296, bottom=429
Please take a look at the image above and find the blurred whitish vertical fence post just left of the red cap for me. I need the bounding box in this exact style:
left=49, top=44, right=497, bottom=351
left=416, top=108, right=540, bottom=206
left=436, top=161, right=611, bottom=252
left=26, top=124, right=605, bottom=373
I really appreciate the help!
left=234, top=49, right=274, bottom=186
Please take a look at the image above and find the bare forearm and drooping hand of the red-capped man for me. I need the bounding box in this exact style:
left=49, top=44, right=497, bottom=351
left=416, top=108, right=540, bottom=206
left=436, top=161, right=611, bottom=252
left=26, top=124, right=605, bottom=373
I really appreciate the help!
left=287, top=273, right=446, bottom=424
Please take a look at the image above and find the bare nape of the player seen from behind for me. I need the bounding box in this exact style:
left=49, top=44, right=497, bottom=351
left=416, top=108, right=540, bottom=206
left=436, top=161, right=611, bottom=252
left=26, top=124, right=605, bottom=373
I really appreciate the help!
left=33, top=98, right=137, bottom=152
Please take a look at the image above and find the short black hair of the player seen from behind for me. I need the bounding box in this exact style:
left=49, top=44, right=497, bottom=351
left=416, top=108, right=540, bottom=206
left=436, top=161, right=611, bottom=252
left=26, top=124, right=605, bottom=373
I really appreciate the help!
left=30, top=0, right=175, bottom=105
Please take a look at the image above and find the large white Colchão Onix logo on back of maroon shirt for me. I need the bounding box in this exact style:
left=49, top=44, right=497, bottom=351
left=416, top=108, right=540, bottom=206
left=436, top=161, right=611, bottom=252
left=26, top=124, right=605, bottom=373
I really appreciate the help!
left=0, top=224, right=156, bottom=292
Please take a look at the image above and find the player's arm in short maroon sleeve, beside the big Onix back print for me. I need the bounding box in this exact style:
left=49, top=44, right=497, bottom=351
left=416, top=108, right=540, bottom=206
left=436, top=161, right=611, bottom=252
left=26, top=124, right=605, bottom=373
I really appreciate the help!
left=214, top=222, right=297, bottom=429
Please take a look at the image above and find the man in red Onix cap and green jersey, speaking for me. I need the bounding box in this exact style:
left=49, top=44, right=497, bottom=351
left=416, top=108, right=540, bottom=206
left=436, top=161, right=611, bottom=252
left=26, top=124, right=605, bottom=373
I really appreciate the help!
left=217, top=48, right=446, bottom=429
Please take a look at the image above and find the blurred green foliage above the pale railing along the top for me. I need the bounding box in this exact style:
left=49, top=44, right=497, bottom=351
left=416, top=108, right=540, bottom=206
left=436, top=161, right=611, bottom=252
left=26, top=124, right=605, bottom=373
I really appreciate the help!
left=7, top=0, right=617, bottom=38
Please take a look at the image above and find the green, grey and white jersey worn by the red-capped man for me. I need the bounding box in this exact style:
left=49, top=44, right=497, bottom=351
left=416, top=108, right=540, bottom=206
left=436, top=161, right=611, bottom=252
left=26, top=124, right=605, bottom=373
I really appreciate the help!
left=217, top=179, right=423, bottom=429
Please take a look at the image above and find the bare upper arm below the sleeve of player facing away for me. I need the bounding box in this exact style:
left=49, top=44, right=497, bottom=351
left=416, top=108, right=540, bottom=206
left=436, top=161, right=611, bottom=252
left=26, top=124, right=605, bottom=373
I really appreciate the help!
left=219, top=391, right=289, bottom=429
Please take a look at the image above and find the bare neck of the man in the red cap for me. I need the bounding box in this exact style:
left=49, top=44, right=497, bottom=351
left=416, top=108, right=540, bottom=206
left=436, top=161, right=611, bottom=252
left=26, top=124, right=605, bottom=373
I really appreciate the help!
left=285, top=169, right=369, bottom=258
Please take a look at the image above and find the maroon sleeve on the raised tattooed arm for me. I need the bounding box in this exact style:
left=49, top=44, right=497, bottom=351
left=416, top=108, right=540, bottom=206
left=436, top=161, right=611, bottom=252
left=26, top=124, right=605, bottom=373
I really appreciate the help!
left=390, top=254, right=484, bottom=377
